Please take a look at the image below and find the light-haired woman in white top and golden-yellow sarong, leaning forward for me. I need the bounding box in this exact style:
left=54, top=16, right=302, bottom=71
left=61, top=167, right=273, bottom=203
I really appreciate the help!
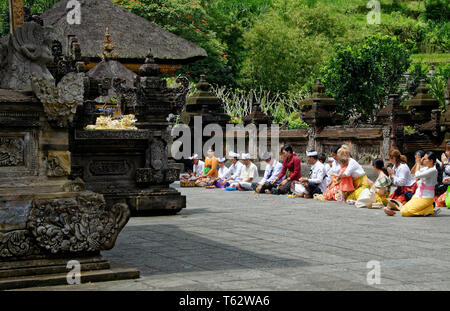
left=338, top=145, right=370, bottom=203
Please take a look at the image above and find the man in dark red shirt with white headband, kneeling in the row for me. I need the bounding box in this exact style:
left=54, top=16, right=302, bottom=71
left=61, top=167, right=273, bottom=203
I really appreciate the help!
left=271, top=145, right=302, bottom=194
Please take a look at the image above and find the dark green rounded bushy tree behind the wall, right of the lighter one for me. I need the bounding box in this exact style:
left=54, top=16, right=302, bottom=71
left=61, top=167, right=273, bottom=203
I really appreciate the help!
left=321, top=35, right=410, bottom=122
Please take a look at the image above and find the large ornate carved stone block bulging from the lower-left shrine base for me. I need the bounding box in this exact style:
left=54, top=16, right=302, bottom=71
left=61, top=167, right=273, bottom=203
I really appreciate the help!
left=27, top=191, right=130, bottom=254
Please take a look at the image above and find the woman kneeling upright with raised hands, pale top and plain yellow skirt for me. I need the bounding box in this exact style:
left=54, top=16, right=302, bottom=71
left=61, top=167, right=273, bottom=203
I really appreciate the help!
left=384, top=152, right=440, bottom=216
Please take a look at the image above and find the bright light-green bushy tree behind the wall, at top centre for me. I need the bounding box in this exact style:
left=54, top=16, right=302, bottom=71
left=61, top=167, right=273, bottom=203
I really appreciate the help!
left=241, top=0, right=344, bottom=92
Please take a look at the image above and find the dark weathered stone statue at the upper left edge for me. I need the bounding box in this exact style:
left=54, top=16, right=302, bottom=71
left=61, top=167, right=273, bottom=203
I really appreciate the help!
left=0, top=22, right=53, bottom=90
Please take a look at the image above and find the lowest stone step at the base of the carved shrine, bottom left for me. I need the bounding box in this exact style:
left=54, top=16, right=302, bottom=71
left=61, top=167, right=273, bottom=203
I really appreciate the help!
left=0, top=263, right=140, bottom=290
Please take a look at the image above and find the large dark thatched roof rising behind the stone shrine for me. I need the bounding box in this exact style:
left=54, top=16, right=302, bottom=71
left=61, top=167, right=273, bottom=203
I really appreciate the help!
left=41, top=0, right=207, bottom=64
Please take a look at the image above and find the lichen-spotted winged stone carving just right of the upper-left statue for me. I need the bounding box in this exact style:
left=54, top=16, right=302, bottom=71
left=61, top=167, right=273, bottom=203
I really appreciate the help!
left=32, top=72, right=84, bottom=127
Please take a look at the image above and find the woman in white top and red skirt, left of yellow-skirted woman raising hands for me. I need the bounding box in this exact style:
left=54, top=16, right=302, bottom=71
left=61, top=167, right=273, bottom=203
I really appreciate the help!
left=387, top=149, right=417, bottom=205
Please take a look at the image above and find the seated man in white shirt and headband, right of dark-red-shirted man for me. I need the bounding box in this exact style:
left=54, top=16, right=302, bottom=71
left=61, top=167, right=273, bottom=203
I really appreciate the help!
left=292, top=151, right=327, bottom=198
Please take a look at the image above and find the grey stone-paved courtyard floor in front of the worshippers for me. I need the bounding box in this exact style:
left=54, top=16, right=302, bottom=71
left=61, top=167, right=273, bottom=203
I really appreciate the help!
left=19, top=185, right=450, bottom=291
